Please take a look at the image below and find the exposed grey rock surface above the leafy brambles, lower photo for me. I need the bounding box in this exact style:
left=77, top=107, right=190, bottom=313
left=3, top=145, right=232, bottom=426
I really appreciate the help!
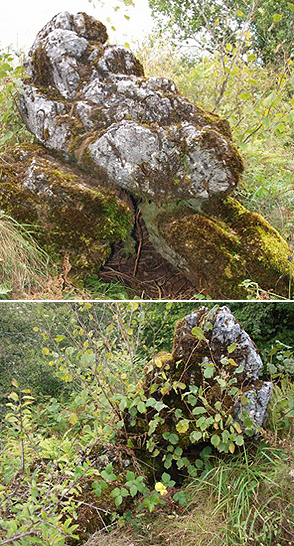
left=173, top=306, right=272, bottom=427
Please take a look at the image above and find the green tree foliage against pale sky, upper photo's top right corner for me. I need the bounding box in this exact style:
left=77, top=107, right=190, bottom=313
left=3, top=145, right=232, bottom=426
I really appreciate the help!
left=149, top=0, right=294, bottom=64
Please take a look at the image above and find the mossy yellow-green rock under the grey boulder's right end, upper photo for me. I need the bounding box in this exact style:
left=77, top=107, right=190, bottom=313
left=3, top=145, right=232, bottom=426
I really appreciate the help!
left=143, top=197, right=291, bottom=299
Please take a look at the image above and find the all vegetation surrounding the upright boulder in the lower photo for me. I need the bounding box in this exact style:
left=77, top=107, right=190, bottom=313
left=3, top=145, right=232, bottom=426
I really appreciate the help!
left=0, top=303, right=294, bottom=546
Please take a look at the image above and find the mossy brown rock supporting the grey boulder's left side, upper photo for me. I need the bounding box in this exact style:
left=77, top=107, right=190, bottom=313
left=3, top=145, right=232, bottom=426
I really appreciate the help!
left=0, top=145, right=133, bottom=271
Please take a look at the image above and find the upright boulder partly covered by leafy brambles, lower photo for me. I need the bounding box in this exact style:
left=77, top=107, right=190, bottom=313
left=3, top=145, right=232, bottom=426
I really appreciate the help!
left=126, top=305, right=272, bottom=452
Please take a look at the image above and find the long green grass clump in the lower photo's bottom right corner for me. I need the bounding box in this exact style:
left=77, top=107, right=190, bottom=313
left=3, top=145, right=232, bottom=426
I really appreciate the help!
left=138, top=442, right=294, bottom=546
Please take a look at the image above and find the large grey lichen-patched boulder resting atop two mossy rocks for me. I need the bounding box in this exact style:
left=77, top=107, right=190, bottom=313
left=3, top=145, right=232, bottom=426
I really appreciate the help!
left=19, top=12, right=243, bottom=202
